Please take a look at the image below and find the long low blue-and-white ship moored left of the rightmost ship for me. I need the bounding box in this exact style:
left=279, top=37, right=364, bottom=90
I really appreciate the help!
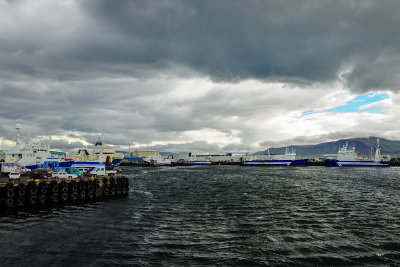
left=242, top=148, right=308, bottom=166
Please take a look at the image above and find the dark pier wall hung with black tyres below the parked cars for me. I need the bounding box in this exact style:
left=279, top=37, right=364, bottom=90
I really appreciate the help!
left=0, top=175, right=129, bottom=214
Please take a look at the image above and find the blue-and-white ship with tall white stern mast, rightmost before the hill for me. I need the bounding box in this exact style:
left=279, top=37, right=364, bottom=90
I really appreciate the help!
left=324, top=139, right=389, bottom=167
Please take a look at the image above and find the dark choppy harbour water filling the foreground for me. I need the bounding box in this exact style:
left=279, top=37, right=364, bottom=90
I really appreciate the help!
left=0, top=166, right=400, bottom=266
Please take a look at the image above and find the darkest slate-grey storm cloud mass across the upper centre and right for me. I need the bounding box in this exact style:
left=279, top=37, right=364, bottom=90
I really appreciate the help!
left=76, top=0, right=400, bottom=90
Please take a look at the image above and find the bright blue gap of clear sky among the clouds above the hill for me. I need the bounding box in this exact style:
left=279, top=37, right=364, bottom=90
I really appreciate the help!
left=302, top=93, right=389, bottom=116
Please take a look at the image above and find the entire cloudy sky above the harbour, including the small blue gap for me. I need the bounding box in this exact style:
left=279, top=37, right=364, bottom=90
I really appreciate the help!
left=0, top=0, right=400, bottom=153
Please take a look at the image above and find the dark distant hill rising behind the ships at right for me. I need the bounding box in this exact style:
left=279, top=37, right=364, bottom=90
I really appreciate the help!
left=254, top=137, right=400, bottom=158
